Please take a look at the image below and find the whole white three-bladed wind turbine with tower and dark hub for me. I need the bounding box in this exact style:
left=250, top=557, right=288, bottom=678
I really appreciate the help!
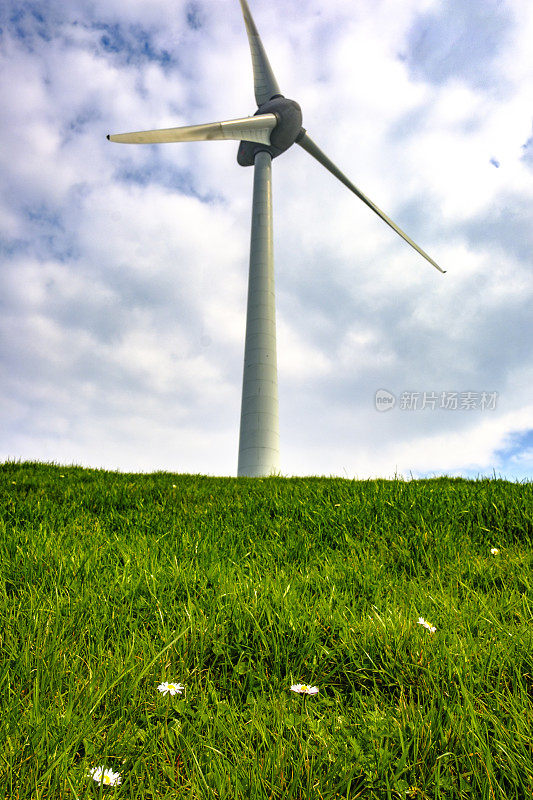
left=107, top=0, right=445, bottom=477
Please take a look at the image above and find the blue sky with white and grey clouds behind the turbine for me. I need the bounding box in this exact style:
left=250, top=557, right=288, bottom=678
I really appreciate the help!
left=0, top=0, right=533, bottom=480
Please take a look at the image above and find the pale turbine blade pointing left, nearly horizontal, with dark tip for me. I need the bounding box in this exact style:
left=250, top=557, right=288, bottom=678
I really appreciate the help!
left=107, top=114, right=278, bottom=144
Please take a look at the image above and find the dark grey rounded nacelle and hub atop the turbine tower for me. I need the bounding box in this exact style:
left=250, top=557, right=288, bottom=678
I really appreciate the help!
left=237, top=94, right=305, bottom=167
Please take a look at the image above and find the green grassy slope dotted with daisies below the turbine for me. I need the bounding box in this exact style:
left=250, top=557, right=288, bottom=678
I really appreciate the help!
left=0, top=462, right=533, bottom=800
